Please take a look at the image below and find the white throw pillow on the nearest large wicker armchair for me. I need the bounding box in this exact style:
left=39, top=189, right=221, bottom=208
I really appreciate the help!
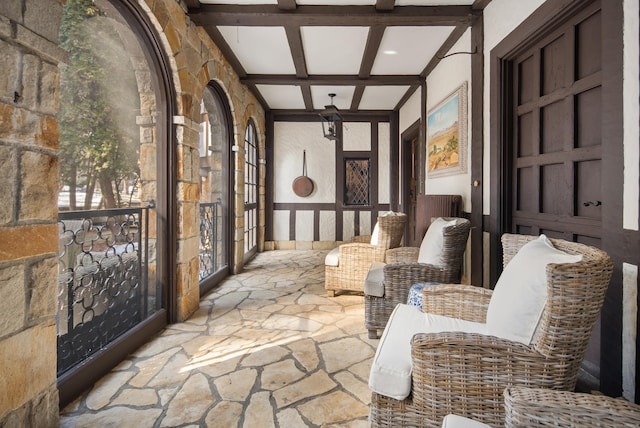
left=487, top=235, right=582, bottom=345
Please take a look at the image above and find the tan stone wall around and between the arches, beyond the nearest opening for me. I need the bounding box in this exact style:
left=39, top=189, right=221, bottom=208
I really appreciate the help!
left=145, top=0, right=265, bottom=320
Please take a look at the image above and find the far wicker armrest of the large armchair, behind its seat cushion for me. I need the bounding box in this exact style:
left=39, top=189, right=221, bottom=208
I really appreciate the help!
left=422, top=284, right=493, bottom=322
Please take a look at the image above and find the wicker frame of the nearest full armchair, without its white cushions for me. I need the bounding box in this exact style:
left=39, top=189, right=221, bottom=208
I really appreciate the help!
left=370, top=235, right=613, bottom=427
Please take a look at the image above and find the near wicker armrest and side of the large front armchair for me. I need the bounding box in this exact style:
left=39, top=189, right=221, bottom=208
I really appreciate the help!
left=411, top=332, right=552, bottom=426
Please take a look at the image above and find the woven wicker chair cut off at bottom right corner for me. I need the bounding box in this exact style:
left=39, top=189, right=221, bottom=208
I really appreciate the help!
left=504, top=387, right=640, bottom=428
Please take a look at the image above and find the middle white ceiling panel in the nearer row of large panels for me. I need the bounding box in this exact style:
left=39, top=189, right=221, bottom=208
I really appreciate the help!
left=300, top=27, right=369, bottom=74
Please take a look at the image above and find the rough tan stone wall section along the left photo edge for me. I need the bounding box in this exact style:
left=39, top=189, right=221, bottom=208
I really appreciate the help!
left=0, top=0, right=65, bottom=427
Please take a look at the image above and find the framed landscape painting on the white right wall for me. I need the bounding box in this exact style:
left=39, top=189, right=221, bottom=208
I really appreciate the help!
left=427, top=82, right=467, bottom=177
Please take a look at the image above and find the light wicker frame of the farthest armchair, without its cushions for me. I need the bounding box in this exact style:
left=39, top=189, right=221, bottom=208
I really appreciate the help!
left=325, top=213, right=407, bottom=297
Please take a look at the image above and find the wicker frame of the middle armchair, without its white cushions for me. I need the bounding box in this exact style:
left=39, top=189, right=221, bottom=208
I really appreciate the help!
left=364, top=218, right=471, bottom=339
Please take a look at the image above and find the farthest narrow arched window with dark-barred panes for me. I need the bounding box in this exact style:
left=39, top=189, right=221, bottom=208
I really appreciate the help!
left=244, top=122, right=258, bottom=260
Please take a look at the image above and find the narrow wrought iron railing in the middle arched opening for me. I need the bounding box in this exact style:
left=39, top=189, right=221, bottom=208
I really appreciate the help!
left=199, top=199, right=223, bottom=281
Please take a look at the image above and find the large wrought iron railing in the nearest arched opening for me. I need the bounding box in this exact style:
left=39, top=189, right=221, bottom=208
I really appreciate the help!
left=57, top=207, right=152, bottom=376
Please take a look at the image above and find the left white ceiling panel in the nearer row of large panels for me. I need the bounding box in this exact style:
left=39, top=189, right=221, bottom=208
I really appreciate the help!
left=218, top=26, right=295, bottom=74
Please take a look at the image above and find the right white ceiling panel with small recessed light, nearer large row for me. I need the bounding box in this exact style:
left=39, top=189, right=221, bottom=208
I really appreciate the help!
left=371, top=27, right=455, bottom=75
